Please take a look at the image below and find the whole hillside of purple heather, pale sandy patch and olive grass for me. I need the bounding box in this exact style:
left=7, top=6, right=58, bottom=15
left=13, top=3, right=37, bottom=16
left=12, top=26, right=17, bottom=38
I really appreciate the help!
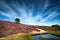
left=0, top=20, right=60, bottom=37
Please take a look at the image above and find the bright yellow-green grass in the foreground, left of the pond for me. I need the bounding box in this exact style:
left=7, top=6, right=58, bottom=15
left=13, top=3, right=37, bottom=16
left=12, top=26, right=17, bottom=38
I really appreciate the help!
left=0, top=33, right=32, bottom=40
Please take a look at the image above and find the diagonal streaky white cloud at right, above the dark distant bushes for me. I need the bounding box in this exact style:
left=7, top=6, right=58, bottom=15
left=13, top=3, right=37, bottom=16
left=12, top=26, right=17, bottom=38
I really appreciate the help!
left=41, top=6, right=60, bottom=22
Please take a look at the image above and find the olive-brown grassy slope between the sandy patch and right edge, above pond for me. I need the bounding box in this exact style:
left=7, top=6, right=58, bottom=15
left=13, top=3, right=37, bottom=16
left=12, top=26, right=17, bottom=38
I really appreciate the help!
left=38, top=26, right=60, bottom=36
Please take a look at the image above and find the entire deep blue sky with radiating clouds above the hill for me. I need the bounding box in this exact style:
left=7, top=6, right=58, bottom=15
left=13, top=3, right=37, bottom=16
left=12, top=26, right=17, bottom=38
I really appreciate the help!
left=0, top=0, right=60, bottom=25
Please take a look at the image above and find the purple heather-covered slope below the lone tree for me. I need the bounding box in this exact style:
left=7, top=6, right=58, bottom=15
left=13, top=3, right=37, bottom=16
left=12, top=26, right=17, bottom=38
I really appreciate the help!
left=0, top=20, right=35, bottom=36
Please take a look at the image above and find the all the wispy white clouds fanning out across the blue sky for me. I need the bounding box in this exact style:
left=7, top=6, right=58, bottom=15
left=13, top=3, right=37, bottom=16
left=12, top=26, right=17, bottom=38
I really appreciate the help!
left=0, top=0, right=59, bottom=25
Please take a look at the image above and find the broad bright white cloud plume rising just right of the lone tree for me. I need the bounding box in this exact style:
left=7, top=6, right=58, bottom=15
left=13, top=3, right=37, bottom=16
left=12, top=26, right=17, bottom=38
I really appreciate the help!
left=19, top=8, right=39, bottom=24
